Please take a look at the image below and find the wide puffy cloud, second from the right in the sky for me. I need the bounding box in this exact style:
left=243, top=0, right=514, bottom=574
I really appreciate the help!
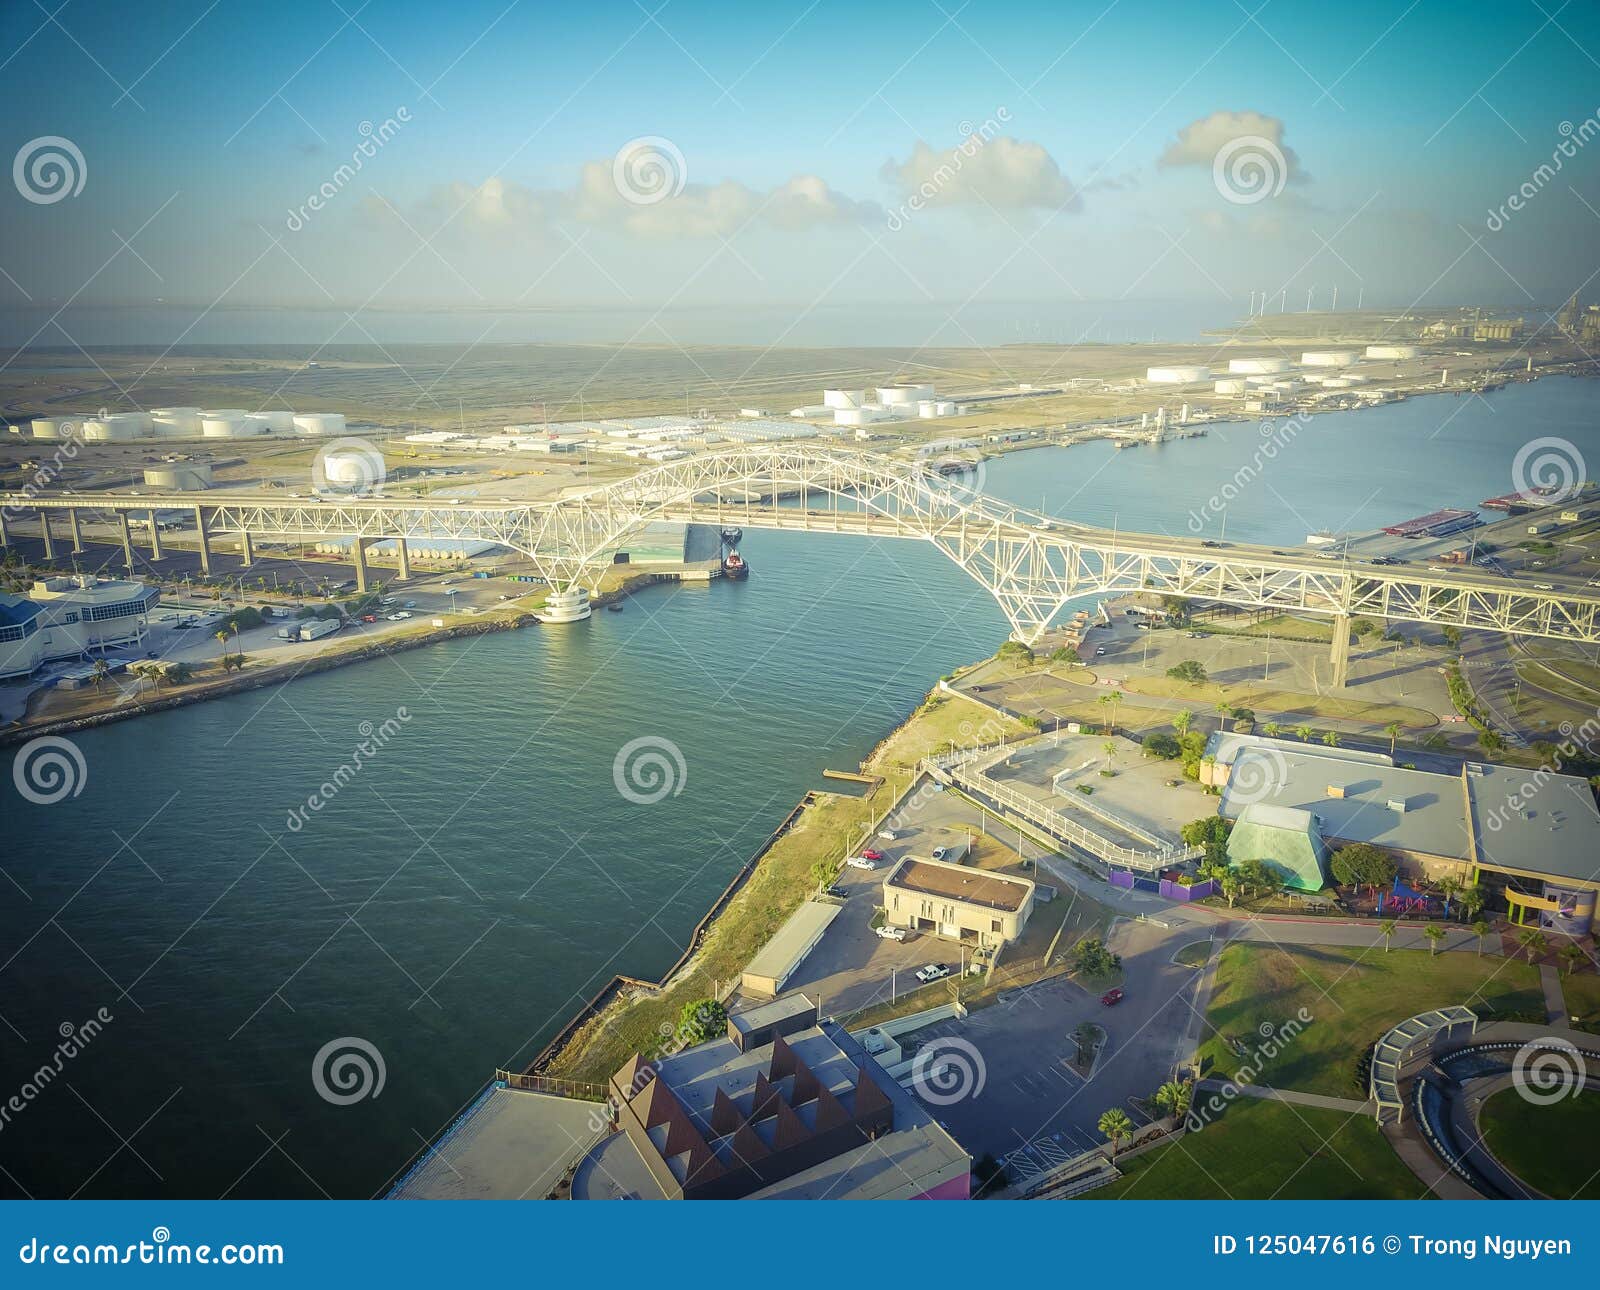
left=882, top=134, right=1082, bottom=211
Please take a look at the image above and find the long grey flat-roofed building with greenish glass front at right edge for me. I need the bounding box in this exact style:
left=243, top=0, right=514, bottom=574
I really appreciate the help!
left=1200, top=733, right=1600, bottom=936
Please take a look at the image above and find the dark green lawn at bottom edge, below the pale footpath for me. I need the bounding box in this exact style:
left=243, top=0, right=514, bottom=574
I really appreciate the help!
left=1083, top=1098, right=1427, bottom=1200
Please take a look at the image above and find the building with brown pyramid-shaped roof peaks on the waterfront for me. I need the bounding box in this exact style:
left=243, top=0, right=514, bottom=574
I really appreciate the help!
left=571, top=996, right=971, bottom=1200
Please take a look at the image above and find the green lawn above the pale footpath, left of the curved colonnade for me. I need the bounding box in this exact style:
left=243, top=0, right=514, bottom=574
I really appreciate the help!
left=1200, top=944, right=1544, bottom=1098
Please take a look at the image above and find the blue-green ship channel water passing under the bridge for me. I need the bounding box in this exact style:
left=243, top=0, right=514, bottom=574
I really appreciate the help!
left=0, top=379, right=1600, bottom=1196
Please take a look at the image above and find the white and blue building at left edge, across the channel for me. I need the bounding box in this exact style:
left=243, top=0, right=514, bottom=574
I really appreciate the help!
left=0, top=575, right=160, bottom=677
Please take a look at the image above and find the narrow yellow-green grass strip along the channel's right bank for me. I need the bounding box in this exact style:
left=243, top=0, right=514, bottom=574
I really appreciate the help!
left=546, top=691, right=1024, bottom=1084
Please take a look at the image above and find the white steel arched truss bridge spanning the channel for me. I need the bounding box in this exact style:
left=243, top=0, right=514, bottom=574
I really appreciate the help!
left=0, top=445, right=1600, bottom=643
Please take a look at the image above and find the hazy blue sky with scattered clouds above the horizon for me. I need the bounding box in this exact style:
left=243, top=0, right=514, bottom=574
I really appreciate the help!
left=0, top=0, right=1600, bottom=346
